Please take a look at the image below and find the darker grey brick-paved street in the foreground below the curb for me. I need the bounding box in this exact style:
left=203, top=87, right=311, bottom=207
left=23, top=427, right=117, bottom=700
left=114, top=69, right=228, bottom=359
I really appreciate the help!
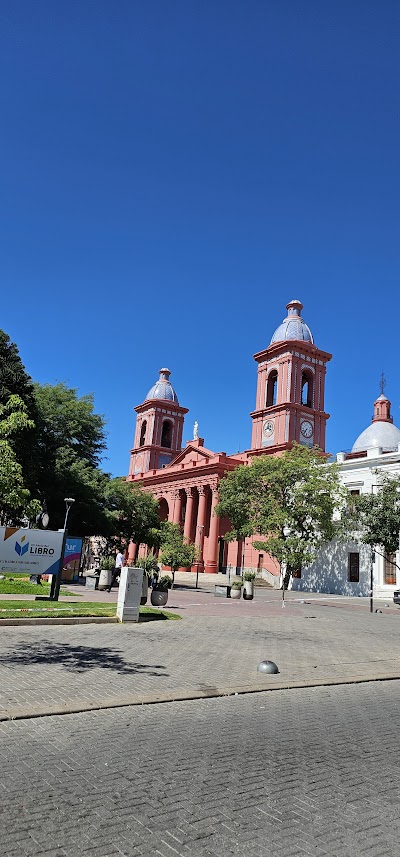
left=0, top=681, right=400, bottom=857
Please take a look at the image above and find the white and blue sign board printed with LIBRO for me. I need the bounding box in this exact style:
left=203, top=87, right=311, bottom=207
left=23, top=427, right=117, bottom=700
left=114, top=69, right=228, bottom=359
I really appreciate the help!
left=0, top=527, right=64, bottom=575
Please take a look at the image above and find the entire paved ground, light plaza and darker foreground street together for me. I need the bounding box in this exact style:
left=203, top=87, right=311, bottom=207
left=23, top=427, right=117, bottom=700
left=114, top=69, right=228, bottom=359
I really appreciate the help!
left=0, top=588, right=400, bottom=857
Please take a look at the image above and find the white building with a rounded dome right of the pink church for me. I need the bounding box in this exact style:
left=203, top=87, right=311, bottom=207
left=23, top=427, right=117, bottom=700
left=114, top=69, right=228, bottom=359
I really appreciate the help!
left=292, top=392, right=400, bottom=600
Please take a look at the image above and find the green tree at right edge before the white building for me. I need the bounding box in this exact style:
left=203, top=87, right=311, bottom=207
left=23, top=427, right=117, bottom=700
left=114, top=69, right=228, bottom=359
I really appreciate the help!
left=349, top=470, right=400, bottom=565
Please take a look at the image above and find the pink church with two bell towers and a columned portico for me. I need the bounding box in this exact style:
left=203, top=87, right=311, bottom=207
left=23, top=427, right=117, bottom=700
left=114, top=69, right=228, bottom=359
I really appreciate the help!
left=127, top=301, right=331, bottom=577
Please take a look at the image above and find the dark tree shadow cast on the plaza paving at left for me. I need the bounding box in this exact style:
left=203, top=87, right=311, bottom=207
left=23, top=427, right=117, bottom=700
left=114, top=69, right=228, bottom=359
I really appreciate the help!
left=1, top=640, right=169, bottom=677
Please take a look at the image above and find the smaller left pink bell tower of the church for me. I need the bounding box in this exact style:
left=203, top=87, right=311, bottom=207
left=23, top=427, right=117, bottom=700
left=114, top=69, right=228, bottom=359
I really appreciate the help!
left=128, top=369, right=188, bottom=481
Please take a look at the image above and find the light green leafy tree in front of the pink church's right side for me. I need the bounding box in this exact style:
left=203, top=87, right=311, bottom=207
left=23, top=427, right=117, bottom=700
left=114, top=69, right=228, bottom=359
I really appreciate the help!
left=216, top=444, right=348, bottom=589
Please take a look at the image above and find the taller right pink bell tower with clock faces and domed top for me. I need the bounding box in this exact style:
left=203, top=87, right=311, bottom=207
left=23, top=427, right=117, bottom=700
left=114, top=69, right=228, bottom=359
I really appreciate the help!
left=249, top=300, right=332, bottom=455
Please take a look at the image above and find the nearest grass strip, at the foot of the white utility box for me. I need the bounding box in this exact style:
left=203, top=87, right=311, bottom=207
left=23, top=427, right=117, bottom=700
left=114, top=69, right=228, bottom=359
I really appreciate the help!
left=0, top=601, right=181, bottom=622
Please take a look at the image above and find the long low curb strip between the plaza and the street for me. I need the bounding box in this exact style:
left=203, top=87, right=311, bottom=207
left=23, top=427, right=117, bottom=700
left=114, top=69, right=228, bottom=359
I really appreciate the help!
left=0, top=672, right=400, bottom=722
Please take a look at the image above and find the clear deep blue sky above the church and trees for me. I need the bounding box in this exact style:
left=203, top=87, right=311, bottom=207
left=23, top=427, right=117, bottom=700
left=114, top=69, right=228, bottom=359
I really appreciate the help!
left=0, top=0, right=400, bottom=474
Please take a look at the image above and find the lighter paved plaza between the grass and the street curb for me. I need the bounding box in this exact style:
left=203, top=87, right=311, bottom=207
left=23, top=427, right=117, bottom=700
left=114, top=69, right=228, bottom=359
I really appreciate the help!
left=0, top=599, right=400, bottom=719
